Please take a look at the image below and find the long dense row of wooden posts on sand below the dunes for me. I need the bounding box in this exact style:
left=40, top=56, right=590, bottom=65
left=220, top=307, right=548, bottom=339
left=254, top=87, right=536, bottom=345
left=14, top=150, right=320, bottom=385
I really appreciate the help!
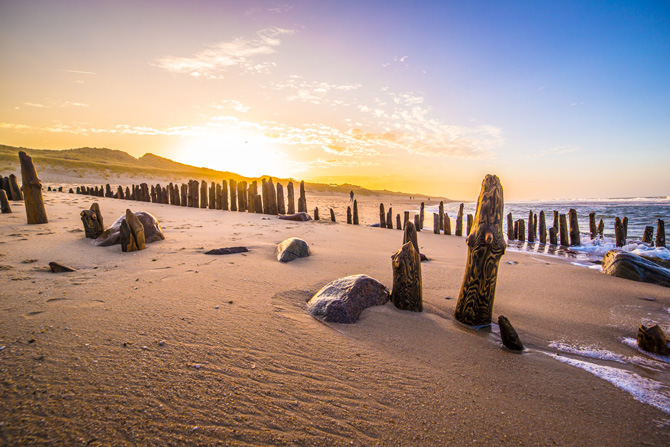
left=69, top=178, right=307, bottom=215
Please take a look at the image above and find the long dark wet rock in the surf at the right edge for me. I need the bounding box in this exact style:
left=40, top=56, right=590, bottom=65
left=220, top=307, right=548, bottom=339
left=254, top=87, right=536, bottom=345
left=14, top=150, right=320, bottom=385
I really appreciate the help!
left=602, top=250, right=670, bottom=287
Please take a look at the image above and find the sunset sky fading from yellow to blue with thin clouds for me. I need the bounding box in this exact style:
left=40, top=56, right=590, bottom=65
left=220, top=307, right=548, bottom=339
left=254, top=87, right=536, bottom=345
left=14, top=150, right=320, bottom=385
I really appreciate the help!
left=0, top=0, right=670, bottom=200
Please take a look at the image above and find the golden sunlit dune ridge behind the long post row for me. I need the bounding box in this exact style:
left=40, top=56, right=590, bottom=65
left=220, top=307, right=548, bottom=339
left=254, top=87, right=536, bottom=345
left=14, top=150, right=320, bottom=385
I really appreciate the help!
left=0, top=145, right=448, bottom=200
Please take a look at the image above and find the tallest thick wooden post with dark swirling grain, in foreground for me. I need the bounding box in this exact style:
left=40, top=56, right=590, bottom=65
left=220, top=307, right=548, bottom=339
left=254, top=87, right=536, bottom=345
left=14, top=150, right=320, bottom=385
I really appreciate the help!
left=454, top=175, right=505, bottom=326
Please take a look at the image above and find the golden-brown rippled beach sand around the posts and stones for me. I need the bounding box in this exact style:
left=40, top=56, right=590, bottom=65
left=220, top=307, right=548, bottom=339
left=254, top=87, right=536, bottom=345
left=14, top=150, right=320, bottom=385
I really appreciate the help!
left=0, top=181, right=670, bottom=446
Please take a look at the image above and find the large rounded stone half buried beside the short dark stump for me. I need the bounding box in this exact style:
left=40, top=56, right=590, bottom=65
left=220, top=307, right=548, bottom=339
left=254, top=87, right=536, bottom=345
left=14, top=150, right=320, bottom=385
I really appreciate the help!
left=307, top=275, right=389, bottom=323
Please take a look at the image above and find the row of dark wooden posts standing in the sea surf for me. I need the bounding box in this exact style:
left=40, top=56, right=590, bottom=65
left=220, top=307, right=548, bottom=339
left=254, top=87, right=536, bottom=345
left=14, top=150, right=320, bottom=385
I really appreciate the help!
left=507, top=209, right=665, bottom=247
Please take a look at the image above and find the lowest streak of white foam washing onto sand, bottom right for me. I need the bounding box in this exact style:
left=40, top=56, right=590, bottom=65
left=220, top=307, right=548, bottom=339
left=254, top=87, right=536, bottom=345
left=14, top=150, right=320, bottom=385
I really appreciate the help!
left=545, top=352, right=670, bottom=414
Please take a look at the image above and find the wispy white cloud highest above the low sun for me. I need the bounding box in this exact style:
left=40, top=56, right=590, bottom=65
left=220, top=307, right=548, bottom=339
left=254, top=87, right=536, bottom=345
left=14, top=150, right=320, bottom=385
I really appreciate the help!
left=158, top=27, right=294, bottom=79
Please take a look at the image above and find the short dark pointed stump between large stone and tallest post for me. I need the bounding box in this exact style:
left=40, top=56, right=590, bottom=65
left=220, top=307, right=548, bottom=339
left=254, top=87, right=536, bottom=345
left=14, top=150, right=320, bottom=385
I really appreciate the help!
left=391, top=242, right=422, bottom=312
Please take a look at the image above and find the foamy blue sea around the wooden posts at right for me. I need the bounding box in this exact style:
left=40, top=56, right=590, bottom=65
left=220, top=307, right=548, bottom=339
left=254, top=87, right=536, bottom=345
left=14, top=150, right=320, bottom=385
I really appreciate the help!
left=422, top=196, right=670, bottom=266
